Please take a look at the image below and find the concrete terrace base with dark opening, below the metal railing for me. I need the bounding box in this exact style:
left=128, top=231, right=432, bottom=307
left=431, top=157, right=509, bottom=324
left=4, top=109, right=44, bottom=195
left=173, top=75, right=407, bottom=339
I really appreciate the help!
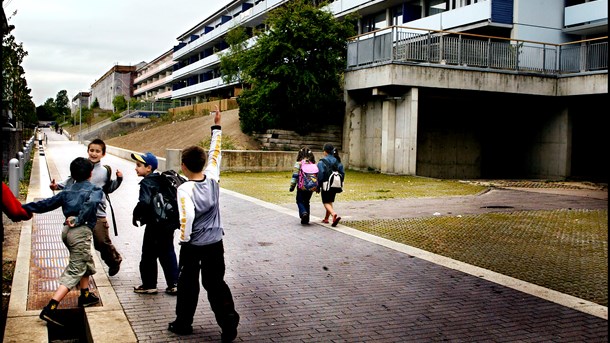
left=343, top=65, right=608, bottom=179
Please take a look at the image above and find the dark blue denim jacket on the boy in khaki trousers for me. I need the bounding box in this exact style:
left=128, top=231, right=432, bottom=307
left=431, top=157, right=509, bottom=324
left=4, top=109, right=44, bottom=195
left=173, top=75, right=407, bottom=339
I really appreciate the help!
left=23, top=180, right=104, bottom=229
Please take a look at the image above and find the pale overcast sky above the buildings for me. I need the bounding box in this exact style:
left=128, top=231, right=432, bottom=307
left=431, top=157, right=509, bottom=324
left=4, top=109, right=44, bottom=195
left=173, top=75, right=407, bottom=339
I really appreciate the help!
left=2, top=0, right=231, bottom=106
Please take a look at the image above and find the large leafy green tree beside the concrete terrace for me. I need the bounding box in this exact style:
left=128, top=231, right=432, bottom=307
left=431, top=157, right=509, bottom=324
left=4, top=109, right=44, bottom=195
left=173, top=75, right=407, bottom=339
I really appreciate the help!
left=221, top=0, right=356, bottom=134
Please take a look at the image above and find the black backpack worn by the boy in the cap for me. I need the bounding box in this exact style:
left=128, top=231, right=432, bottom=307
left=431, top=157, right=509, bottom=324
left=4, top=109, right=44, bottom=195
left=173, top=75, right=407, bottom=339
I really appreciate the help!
left=151, top=170, right=186, bottom=230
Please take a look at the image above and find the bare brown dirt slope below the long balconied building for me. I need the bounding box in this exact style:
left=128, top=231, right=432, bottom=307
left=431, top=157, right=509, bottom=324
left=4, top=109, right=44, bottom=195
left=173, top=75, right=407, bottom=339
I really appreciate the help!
left=105, top=109, right=261, bottom=157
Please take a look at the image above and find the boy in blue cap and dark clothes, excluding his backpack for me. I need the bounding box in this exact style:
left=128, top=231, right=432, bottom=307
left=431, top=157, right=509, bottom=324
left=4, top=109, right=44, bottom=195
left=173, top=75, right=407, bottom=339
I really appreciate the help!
left=131, top=152, right=178, bottom=295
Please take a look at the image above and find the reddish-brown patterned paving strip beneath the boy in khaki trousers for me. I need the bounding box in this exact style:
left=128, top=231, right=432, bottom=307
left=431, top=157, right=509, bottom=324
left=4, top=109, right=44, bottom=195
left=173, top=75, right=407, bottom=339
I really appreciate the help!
left=27, top=204, right=101, bottom=310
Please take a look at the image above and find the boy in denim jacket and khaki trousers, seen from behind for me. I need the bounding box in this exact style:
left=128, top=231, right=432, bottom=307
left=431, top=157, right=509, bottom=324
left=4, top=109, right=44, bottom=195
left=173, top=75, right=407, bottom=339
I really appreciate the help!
left=23, top=157, right=104, bottom=326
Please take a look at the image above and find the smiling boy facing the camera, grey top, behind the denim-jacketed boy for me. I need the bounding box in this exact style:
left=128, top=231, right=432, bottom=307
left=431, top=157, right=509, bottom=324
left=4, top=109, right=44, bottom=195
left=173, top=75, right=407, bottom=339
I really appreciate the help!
left=49, top=138, right=123, bottom=276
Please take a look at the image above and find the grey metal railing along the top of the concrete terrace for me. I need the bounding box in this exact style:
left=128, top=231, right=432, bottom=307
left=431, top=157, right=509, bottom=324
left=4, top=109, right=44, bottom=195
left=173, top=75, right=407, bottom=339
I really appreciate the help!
left=347, top=26, right=608, bottom=75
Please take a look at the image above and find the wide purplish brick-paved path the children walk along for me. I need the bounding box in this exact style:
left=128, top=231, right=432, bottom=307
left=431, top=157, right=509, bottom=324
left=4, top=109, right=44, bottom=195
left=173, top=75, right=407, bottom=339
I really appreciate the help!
left=40, top=133, right=608, bottom=342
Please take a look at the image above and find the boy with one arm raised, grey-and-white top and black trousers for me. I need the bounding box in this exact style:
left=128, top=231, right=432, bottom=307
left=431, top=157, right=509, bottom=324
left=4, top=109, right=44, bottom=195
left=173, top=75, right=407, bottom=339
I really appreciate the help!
left=168, top=106, right=239, bottom=342
